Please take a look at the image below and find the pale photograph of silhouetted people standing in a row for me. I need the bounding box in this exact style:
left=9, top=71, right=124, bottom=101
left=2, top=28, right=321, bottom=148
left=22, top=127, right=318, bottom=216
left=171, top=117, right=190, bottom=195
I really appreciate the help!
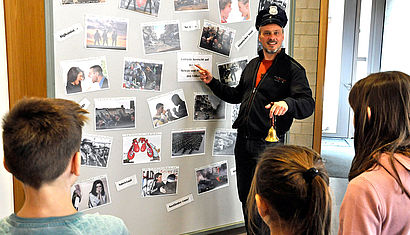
left=85, top=15, right=128, bottom=50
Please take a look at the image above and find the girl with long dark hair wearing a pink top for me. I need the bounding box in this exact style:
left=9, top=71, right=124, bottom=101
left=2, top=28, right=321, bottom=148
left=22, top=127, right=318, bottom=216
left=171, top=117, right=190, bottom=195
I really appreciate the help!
left=339, top=71, right=410, bottom=234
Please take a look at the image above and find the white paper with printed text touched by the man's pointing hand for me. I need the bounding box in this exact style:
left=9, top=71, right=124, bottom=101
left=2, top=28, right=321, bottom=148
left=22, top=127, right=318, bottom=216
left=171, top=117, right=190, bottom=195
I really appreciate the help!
left=178, top=52, right=212, bottom=82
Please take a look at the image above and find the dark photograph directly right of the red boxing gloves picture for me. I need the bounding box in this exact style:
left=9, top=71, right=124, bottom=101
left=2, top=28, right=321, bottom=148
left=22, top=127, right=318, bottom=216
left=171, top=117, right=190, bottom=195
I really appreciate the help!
left=171, top=129, right=205, bottom=158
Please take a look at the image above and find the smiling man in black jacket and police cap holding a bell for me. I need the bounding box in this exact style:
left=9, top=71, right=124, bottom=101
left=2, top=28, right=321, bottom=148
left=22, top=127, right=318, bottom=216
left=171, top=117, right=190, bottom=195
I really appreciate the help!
left=197, top=4, right=315, bottom=231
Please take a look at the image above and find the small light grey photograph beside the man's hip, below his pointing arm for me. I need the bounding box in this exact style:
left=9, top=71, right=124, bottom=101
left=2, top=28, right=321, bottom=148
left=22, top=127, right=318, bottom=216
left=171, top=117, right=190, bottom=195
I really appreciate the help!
left=212, top=129, right=236, bottom=156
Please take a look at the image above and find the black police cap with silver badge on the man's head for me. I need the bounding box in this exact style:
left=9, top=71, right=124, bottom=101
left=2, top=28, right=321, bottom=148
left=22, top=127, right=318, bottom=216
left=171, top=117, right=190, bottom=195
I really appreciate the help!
left=255, top=4, right=288, bottom=30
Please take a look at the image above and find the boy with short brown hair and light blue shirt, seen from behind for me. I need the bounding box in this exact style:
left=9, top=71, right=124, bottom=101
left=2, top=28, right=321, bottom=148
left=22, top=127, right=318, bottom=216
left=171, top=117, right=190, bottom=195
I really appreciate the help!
left=0, top=98, right=128, bottom=235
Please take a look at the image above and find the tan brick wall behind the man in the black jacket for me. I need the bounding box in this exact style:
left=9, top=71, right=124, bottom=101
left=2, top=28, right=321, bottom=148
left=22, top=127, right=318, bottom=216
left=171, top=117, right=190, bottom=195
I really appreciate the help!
left=289, top=0, right=320, bottom=147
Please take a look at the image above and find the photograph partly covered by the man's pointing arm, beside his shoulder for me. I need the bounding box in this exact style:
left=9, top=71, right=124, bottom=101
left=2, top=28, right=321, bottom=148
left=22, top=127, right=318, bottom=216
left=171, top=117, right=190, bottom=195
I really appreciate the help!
left=218, top=57, right=248, bottom=87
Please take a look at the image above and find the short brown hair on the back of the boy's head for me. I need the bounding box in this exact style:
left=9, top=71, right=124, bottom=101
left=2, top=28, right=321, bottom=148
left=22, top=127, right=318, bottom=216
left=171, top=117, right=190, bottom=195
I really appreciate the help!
left=3, top=98, right=88, bottom=189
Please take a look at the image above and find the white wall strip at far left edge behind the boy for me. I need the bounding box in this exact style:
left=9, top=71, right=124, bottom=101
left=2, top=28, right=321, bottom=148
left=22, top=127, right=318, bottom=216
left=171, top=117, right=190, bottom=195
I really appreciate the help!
left=0, top=1, right=13, bottom=218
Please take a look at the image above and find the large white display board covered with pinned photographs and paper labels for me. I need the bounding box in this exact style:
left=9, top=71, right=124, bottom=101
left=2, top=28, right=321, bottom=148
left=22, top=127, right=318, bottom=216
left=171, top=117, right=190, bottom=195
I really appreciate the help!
left=52, top=0, right=292, bottom=234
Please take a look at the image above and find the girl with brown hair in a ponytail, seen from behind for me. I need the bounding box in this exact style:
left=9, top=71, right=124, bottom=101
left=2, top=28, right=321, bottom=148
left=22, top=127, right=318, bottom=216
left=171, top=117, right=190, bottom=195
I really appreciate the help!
left=247, top=145, right=332, bottom=235
